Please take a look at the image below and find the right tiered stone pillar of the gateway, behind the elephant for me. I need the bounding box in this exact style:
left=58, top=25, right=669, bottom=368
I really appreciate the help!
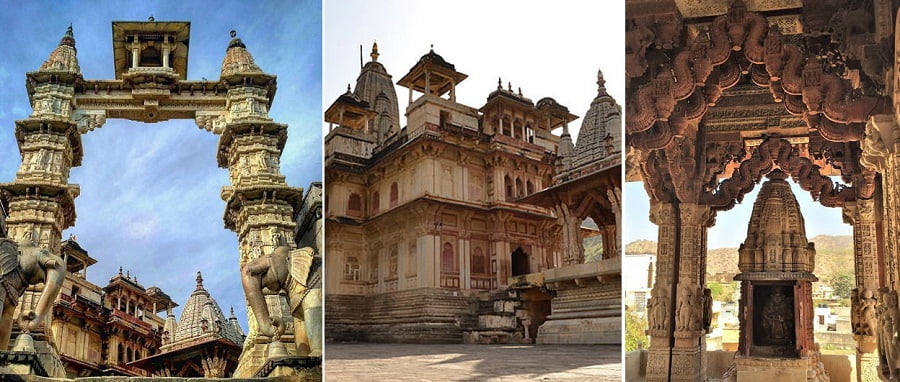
left=217, top=32, right=310, bottom=377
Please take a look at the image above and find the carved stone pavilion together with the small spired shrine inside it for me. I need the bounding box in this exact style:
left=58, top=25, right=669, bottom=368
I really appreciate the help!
left=625, top=0, right=900, bottom=381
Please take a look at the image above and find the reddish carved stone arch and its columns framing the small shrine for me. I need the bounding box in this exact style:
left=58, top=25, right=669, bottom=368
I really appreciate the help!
left=625, top=0, right=900, bottom=381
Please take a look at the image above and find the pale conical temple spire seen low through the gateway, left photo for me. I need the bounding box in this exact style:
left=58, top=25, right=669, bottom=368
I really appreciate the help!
left=167, top=272, right=244, bottom=347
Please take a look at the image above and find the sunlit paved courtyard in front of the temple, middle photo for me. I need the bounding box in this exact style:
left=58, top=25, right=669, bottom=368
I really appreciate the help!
left=325, top=344, right=622, bottom=382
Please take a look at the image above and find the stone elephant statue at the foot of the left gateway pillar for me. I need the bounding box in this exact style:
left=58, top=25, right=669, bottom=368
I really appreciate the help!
left=0, top=238, right=66, bottom=350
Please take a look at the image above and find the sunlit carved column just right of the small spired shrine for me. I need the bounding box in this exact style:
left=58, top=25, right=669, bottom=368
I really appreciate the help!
left=843, top=199, right=879, bottom=382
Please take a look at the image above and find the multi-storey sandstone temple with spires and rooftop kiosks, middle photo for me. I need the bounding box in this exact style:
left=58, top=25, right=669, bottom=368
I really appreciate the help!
left=324, top=45, right=621, bottom=344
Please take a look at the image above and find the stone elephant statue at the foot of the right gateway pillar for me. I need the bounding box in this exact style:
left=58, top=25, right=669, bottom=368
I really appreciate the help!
left=241, top=246, right=322, bottom=357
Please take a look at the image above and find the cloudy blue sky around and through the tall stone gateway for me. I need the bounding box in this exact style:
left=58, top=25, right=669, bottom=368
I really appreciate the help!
left=0, top=0, right=322, bottom=330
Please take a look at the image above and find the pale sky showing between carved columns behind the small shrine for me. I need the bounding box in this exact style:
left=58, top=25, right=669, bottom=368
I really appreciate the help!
left=624, top=180, right=853, bottom=249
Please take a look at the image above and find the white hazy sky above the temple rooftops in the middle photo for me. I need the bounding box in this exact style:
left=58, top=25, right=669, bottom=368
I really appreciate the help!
left=322, top=0, right=625, bottom=138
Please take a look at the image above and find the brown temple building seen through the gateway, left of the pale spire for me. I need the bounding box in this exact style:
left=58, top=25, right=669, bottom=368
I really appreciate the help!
left=23, top=238, right=178, bottom=378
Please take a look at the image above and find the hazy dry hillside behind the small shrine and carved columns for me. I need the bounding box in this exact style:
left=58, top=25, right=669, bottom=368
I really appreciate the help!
left=625, top=235, right=853, bottom=282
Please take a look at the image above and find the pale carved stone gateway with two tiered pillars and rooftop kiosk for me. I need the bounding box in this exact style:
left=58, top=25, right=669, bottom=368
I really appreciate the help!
left=0, top=20, right=305, bottom=374
